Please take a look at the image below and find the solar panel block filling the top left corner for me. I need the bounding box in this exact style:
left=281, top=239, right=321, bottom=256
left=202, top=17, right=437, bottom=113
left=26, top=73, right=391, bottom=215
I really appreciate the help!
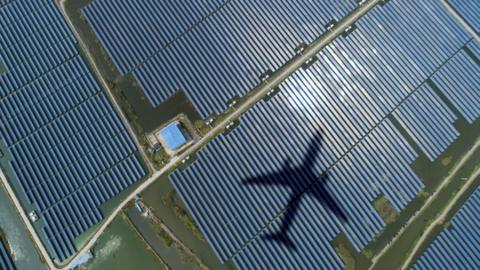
left=0, top=0, right=75, bottom=97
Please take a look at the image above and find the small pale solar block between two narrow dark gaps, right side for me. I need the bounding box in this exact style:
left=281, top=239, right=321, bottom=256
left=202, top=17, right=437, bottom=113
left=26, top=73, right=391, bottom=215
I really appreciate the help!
left=393, top=84, right=460, bottom=161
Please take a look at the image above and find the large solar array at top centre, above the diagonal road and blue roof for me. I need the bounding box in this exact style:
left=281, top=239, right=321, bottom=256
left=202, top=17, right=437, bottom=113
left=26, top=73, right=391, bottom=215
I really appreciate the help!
left=84, top=0, right=356, bottom=117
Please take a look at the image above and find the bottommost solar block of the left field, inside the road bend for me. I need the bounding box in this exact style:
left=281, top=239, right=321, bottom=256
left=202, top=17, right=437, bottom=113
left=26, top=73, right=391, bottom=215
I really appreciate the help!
left=44, top=156, right=145, bottom=258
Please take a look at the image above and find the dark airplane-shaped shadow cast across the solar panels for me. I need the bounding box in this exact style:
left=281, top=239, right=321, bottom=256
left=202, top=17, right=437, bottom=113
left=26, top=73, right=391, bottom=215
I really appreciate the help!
left=242, top=132, right=347, bottom=249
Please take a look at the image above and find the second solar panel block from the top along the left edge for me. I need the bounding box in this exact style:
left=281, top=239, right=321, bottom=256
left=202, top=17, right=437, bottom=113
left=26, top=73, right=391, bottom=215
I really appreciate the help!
left=0, top=56, right=99, bottom=148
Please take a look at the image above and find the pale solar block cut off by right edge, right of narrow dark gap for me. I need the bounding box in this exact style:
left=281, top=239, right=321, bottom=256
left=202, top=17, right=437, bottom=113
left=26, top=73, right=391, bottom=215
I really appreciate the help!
left=433, top=48, right=480, bottom=123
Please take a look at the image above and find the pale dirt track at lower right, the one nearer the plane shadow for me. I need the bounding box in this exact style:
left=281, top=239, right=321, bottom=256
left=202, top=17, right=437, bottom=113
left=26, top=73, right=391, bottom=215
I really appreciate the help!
left=369, top=140, right=480, bottom=269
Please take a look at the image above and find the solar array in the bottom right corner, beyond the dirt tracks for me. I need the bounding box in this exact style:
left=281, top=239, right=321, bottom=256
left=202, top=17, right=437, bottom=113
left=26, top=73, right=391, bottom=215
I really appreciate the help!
left=412, top=188, right=480, bottom=269
